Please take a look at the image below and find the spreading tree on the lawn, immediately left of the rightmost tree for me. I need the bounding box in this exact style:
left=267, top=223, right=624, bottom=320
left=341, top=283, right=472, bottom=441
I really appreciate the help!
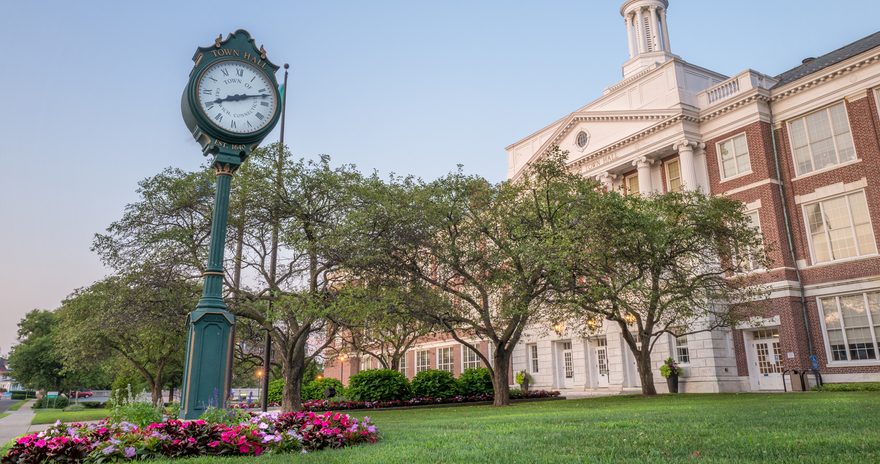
left=339, top=160, right=567, bottom=406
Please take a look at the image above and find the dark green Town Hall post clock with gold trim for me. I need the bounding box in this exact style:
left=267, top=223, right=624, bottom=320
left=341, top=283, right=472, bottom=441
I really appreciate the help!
left=180, top=30, right=281, bottom=419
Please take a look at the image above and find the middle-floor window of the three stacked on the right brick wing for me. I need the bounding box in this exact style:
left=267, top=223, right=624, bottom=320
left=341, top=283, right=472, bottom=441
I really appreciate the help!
left=804, top=191, right=877, bottom=263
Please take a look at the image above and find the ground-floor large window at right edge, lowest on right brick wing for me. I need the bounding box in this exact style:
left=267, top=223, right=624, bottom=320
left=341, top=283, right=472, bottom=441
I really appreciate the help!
left=819, top=292, right=880, bottom=361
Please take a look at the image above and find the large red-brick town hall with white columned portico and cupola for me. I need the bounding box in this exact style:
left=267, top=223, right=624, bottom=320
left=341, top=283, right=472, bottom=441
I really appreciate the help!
left=326, top=0, right=880, bottom=392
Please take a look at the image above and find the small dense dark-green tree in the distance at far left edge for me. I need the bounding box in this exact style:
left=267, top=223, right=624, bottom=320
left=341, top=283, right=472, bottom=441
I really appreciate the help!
left=9, top=309, right=64, bottom=390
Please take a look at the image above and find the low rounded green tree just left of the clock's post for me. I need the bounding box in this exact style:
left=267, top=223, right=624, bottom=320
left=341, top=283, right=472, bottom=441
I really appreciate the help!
left=59, top=268, right=199, bottom=405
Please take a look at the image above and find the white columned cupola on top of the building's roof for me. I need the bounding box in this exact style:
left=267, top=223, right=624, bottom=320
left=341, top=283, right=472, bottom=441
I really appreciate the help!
left=620, top=0, right=672, bottom=78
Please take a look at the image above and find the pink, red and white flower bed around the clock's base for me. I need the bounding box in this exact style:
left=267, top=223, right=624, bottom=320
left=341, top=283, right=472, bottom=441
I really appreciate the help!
left=0, top=412, right=378, bottom=464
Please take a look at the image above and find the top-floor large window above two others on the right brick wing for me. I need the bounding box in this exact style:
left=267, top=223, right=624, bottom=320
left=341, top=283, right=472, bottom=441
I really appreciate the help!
left=788, top=103, right=856, bottom=176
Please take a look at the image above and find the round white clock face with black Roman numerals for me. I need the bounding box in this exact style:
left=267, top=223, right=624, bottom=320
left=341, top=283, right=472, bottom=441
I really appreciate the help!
left=196, top=60, right=278, bottom=134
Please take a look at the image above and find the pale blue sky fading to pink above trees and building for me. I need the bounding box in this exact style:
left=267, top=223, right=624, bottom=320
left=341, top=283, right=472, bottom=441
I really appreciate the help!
left=0, top=0, right=880, bottom=354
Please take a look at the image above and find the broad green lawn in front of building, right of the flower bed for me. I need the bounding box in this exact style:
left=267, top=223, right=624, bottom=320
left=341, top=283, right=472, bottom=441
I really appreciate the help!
left=148, top=392, right=880, bottom=464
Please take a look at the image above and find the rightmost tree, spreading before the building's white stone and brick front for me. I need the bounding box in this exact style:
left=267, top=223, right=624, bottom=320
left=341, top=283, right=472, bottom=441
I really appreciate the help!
left=543, top=157, right=767, bottom=395
